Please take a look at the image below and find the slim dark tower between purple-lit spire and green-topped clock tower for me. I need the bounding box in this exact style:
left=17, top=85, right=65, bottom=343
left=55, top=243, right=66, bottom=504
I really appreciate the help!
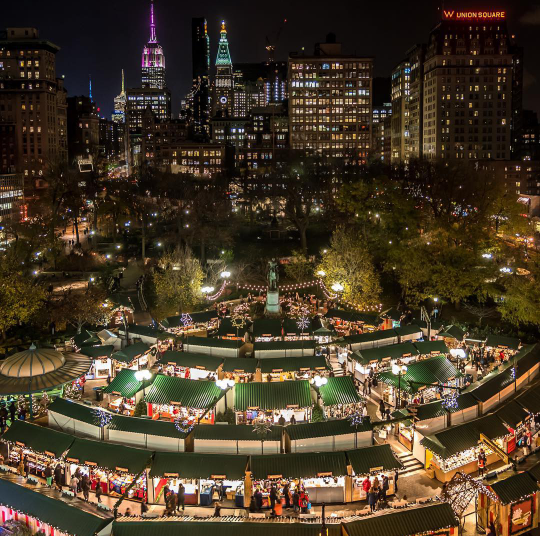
left=189, top=17, right=210, bottom=140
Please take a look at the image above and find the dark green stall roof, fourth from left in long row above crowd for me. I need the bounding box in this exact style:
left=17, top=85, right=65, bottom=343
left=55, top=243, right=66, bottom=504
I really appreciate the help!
left=250, top=452, right=347, bottom=479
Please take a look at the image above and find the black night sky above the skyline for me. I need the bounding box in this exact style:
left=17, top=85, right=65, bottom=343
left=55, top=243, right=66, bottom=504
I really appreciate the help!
left=1, top=0, right=540, bottom=117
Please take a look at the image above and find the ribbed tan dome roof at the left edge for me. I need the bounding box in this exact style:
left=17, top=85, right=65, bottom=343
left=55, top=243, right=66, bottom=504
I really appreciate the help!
left=0, top=344, right=66, bottom=378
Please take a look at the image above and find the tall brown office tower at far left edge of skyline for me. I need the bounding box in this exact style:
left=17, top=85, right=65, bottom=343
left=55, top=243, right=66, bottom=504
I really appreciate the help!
left=0, top=28, right=67, bottom=193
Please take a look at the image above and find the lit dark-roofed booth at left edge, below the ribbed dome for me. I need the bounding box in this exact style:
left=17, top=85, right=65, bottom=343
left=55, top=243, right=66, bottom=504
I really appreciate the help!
left=2, top=421, right=74, bottom=484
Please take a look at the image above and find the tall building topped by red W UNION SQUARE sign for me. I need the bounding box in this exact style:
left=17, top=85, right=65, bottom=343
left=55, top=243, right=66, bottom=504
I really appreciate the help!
left=423, top=10, right=521, bottom=160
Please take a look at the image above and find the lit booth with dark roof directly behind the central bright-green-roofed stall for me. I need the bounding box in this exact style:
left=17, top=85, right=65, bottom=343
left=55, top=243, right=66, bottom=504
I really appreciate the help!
left=259, top=356, right=330, bottom=382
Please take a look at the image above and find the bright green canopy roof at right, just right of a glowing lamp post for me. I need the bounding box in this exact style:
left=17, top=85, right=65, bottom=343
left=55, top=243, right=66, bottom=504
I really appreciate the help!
left=377, top=356, right=460, bottom=393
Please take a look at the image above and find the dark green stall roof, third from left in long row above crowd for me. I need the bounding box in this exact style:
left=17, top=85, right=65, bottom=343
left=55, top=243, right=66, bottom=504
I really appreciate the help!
left=150, top=452, right=248, bottom=480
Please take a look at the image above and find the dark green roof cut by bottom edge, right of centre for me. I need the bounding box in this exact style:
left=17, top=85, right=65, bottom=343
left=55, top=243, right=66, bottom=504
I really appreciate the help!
left=343, top=503, right=459, bottom=536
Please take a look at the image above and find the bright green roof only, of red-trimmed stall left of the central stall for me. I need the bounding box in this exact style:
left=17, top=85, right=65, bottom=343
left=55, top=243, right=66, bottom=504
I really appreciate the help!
left=145, top=374, right=225, bottom=409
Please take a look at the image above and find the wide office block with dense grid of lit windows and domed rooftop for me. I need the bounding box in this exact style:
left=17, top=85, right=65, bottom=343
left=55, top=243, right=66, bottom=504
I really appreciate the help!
left=288, top=34, right=373, bottom=163
